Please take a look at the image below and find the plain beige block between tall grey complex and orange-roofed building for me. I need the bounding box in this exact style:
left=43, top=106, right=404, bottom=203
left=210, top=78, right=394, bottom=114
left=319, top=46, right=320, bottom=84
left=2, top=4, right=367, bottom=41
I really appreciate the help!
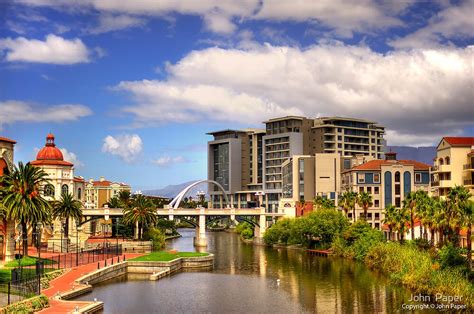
left=279, top=153, right=341, bottom=216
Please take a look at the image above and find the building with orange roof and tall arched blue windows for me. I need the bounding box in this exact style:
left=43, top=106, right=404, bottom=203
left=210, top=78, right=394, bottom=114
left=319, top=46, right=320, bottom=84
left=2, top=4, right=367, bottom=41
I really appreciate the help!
left=341, top=152, right=430, bottom=229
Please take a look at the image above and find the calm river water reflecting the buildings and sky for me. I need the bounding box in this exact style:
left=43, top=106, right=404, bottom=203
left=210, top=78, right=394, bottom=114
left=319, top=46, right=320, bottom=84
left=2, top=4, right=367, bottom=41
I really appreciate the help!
left=75, top=229, right=418, bottom=313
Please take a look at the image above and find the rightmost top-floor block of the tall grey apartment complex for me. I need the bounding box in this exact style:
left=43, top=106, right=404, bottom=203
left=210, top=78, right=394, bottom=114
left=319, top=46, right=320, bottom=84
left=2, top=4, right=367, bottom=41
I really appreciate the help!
left=311, top=117, right=386, bottom=159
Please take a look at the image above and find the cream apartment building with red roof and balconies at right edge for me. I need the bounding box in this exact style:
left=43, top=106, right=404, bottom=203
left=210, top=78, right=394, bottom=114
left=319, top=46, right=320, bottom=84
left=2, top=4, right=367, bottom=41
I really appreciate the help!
left=431, top=137, right=474, bottom=197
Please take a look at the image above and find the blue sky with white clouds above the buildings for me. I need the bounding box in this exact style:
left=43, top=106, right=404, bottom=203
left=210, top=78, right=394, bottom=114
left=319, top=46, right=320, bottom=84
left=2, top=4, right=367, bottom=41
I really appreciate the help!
left=0, top=0, right=474, bottom=190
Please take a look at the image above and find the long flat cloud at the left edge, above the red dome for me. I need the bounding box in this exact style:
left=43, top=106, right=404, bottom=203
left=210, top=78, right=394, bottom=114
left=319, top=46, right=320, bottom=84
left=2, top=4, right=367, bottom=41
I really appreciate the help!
left=0, top=100, right=92, bottom=129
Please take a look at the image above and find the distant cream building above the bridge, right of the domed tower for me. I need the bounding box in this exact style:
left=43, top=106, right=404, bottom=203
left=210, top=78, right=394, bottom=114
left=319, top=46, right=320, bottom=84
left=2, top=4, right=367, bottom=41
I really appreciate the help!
left=85, top=177, right=132, bottom=208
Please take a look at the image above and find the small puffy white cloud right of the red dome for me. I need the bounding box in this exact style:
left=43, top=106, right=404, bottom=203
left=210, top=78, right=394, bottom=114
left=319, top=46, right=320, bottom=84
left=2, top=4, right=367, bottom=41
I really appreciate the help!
left=102, top=134, right=143, bottom=163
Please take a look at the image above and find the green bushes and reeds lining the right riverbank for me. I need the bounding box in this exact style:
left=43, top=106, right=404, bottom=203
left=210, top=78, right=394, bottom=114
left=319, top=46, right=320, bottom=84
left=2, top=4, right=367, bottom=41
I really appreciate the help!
left=264, top=209, right=474, bottom=309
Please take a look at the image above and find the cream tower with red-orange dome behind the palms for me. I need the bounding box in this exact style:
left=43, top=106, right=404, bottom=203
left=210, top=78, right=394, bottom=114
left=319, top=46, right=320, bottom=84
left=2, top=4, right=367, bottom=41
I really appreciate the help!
left=31, top=133, right=74, bottom=200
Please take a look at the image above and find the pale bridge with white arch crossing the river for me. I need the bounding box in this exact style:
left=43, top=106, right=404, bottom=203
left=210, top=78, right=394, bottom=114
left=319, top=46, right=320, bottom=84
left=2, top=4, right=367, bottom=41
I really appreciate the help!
left=82, top=180, right=285, bottom=246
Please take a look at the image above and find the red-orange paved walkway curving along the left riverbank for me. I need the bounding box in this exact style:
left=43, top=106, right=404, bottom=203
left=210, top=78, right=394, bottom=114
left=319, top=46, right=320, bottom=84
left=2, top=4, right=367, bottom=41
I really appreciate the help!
left=39, top=253, right=143, bottom=313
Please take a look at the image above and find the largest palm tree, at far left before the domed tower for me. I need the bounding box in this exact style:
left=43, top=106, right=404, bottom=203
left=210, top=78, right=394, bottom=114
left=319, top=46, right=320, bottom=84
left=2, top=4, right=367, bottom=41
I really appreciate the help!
left=1, top=162, right=51, bottom=256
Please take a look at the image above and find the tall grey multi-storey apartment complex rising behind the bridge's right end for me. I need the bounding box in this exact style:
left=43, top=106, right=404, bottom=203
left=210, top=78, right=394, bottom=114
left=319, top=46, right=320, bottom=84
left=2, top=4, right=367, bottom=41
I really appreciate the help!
left=208, top=116, right=385, bottom=212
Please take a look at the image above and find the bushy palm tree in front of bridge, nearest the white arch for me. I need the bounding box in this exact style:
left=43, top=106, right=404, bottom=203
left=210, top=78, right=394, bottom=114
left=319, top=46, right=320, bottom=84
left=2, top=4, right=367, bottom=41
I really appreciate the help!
left=123, top=195, right=158, bottom=239
